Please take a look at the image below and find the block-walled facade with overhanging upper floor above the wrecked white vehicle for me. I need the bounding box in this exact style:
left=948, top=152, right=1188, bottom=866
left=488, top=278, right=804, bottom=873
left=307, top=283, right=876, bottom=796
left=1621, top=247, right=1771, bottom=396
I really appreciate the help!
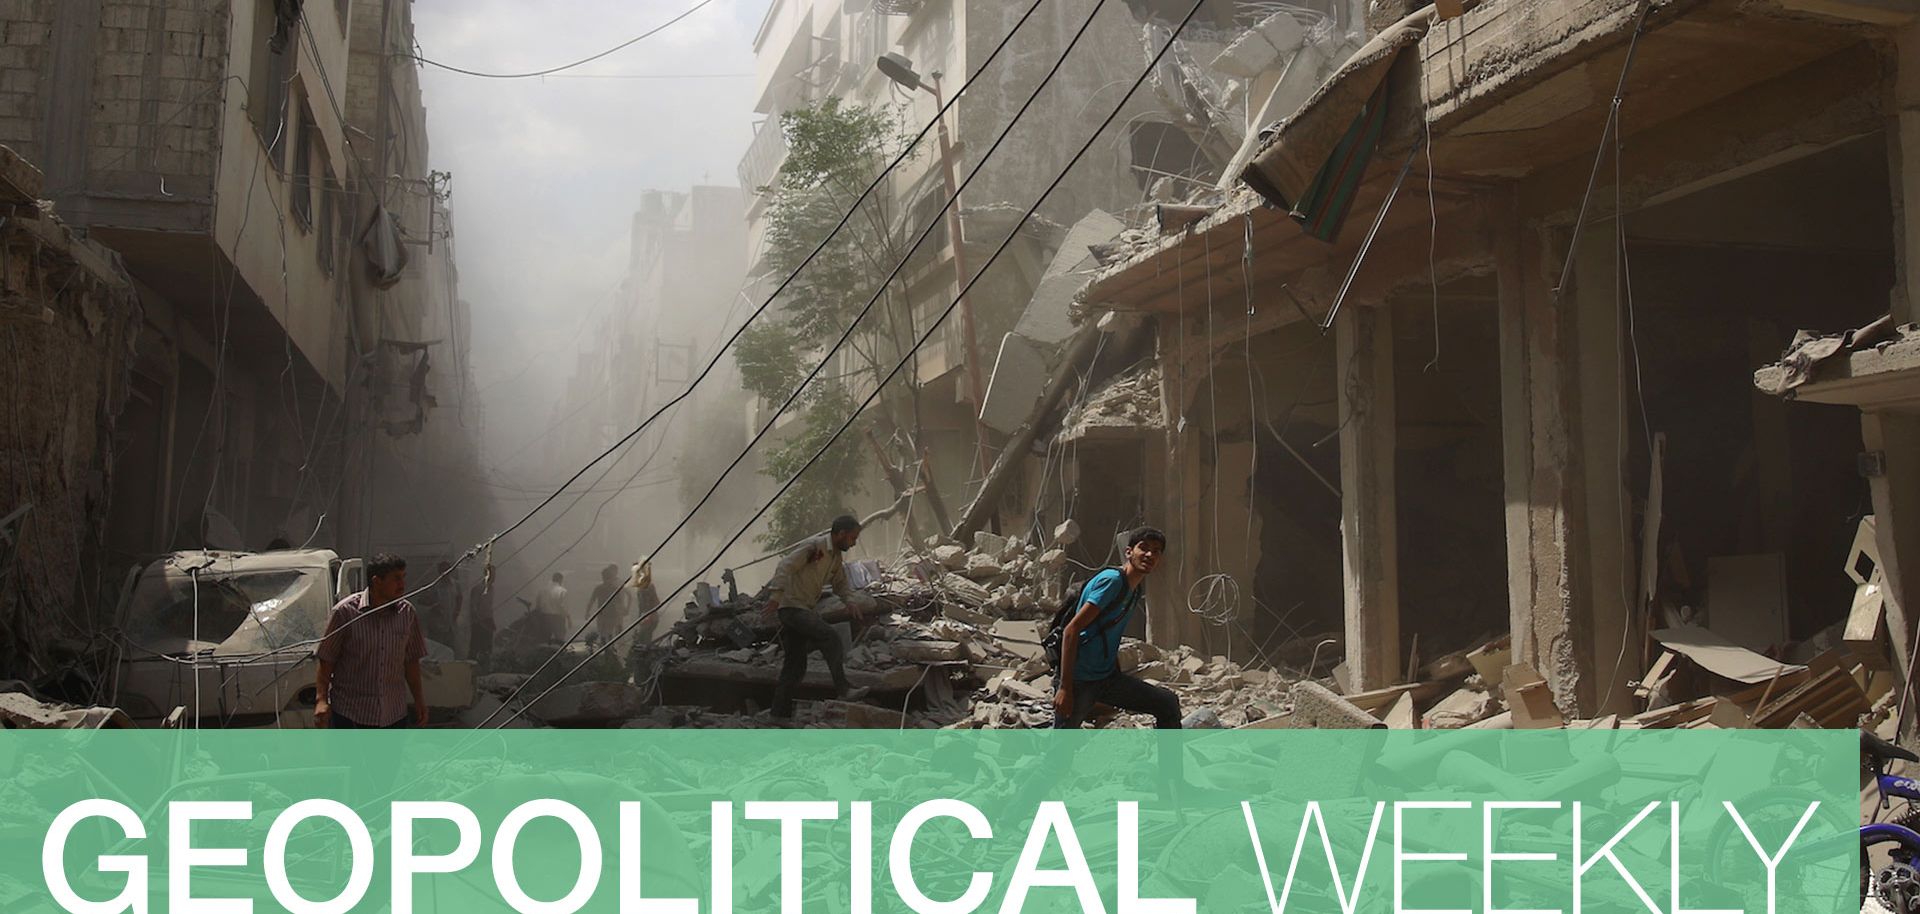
left=0, top=0, right=486, bottom=672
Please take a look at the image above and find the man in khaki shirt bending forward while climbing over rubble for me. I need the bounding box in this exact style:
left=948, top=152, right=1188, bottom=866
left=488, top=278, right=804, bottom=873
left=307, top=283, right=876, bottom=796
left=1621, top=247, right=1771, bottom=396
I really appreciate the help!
left=766, top=515, right=866, bottom=718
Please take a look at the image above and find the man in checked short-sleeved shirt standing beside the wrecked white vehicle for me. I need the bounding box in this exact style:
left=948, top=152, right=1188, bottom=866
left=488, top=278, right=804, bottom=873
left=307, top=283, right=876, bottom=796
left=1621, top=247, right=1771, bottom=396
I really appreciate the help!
left=313, top=553, right=426, bottom=730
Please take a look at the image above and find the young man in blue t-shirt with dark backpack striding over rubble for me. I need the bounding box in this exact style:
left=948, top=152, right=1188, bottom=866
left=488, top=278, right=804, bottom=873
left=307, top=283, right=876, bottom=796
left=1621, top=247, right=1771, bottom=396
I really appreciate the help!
left=1054, top=526, right=1181, bottom=730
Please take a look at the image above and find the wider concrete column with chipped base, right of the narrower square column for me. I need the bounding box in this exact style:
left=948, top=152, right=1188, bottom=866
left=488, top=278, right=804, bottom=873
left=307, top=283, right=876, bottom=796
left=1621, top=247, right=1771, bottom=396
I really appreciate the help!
left=1490, top=210, right=1592, bottom=712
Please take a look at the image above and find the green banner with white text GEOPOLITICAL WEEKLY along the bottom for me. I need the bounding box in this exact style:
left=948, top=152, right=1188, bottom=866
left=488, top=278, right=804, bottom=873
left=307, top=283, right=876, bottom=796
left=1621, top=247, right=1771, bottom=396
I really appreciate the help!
left=0, top=730, right=1860, bottom=914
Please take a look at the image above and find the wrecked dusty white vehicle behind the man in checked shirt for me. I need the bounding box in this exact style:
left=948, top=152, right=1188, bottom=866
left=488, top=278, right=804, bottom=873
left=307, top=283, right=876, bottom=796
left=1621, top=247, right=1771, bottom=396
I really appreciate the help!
left=113, top=549, right=474, bottom=728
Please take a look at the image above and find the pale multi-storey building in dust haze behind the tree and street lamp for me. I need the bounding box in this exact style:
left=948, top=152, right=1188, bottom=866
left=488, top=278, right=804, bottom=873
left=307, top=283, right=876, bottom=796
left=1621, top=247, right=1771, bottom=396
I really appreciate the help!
left=739, top=0, right=1185, bottom=543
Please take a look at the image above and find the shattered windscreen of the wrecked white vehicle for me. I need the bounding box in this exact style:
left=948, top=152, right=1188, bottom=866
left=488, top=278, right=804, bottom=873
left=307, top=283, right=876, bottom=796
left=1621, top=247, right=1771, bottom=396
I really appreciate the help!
left=127, top=570, right=328, bottom=653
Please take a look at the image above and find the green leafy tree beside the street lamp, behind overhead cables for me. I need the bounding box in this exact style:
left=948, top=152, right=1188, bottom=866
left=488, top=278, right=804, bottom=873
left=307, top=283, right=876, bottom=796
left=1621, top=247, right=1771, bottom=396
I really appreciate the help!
left=733, top=98, right=914, bottom=545
